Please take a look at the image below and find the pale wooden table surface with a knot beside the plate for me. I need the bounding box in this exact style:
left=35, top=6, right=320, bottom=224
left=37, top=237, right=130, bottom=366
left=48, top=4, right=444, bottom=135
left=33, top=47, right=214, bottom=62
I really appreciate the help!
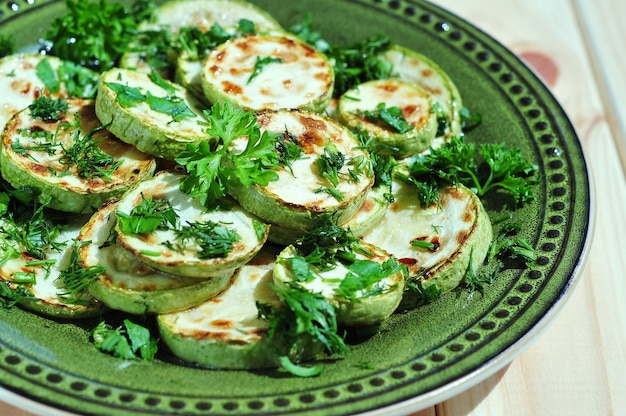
left=0, top=0, right=626, bottom=416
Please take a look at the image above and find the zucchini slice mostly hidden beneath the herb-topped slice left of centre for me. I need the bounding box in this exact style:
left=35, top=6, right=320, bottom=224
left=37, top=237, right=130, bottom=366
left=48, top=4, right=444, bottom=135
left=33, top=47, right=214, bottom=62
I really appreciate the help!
left=78, top=201, right=231, bottom=315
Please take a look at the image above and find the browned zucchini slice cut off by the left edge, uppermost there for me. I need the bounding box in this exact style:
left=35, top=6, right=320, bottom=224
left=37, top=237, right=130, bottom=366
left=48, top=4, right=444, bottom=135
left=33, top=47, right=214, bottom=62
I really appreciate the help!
left=0, top=53, right=63, bottom=128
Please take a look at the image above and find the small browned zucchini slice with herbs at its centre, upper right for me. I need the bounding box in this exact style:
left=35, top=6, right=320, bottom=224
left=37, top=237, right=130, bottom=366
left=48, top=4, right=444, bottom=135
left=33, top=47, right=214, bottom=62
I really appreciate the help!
left=338, top=79, right=437, bottom=158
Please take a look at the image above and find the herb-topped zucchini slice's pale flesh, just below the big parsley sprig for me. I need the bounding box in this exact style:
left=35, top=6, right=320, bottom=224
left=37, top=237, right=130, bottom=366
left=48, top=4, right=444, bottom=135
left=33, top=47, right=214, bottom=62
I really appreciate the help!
left=116, top=171, right=269, bottom=279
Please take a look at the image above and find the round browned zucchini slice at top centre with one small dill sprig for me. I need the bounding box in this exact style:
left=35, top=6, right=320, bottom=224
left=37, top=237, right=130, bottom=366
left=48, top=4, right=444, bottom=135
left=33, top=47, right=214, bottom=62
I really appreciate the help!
left=202, top=34, right=335, bottom=113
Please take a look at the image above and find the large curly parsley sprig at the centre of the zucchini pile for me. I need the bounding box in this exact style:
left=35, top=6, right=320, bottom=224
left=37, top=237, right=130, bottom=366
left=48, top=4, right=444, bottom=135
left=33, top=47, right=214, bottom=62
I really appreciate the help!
left=176, top=102, right=280, bottom=207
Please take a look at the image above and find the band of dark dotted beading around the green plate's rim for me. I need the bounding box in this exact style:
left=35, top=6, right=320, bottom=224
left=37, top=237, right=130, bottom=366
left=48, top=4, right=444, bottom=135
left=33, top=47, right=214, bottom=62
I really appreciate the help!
left=0, top=0, right=573, bottom=414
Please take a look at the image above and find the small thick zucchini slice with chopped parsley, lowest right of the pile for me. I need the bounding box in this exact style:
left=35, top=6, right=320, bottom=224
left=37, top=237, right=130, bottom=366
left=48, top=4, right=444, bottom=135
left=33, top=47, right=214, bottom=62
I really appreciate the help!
left=274, top=243, right=404, bottom=326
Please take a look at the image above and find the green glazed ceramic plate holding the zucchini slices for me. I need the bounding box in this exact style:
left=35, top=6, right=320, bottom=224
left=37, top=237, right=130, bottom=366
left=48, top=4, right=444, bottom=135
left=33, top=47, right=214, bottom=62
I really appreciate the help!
left=0, top=0, right=592, bottom=415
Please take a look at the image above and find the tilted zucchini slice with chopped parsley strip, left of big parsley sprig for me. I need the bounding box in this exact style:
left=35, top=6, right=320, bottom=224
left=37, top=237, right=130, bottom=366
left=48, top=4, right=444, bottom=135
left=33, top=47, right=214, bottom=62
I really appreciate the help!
left=96, top=68, right=215, bottom=160
